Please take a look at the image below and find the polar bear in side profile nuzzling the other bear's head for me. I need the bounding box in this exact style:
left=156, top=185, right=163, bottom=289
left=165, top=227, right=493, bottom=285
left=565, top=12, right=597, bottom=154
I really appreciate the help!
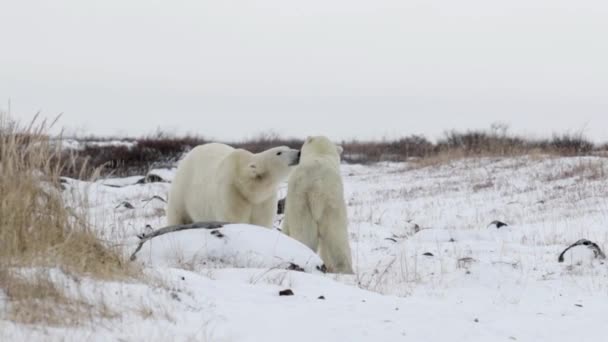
left=167, top=143, right=300, bottom=228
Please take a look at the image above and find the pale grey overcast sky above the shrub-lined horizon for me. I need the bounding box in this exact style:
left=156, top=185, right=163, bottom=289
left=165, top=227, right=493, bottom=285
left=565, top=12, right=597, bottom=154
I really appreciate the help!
left=0, top=0, right=608, bottom=141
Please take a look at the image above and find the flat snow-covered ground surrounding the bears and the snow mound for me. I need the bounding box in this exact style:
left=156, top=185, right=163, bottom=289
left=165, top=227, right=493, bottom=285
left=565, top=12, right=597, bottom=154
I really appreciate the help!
left=0, top=156, right=608, bottom=342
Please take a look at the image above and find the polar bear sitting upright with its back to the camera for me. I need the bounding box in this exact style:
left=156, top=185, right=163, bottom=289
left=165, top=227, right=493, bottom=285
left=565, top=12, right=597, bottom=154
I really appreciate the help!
left=282, top=136, right=353, bottom=273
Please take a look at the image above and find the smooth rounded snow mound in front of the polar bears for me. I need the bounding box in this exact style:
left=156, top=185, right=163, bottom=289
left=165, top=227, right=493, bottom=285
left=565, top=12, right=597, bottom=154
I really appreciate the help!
left=130, top=224, right=323, bottom=272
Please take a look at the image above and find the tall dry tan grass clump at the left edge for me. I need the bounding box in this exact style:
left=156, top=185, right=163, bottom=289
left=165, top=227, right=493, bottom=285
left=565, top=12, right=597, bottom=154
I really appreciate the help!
left=0, top=114, right=135, bottom=324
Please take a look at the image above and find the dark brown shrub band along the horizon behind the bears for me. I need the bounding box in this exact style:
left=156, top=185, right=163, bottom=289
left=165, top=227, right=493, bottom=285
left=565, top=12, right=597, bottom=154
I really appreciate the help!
left=64, top=124, right=608, bottom=178
